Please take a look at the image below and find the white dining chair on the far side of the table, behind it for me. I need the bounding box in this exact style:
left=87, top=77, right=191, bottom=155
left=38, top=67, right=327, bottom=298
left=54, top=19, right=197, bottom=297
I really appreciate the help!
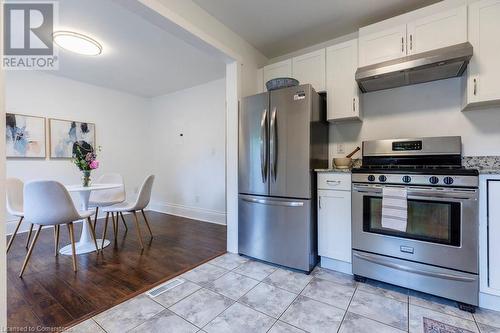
left=89, top=173, right=128, bottom=232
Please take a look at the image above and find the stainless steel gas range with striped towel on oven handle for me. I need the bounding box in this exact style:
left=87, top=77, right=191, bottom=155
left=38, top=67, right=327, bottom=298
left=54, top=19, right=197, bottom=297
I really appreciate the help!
left=352, top=137, right=479, bottom=311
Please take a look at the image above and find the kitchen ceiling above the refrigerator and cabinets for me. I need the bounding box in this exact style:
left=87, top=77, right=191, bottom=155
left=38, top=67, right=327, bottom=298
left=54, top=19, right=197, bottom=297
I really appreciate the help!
left=193, top=0, right=439, bottom=58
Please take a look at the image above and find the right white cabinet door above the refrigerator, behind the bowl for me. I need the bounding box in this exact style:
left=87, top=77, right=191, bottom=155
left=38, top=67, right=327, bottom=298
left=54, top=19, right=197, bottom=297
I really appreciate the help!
left=292, top=49, right=326, bottom=92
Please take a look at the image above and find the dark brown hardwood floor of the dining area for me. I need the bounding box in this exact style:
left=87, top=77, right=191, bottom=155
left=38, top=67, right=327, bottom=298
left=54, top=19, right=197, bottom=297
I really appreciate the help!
left=7, top=212, right=226, bottom=328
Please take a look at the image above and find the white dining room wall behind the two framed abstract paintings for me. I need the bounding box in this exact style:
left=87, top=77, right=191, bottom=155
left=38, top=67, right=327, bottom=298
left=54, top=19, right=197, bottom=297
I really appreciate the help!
left=5, top=71, right=152, bottom=232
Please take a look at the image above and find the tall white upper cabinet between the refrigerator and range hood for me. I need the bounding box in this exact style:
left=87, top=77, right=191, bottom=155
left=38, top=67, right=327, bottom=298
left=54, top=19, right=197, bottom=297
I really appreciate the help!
left=326, top=39, right=361, bottom=121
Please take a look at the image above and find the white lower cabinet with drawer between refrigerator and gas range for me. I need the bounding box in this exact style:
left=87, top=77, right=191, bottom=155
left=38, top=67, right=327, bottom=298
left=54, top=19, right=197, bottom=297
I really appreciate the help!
left=318, top=173, right=351, bottom=263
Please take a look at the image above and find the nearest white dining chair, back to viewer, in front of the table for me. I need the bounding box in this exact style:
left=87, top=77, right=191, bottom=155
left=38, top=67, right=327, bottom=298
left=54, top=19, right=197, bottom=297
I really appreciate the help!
left=19, top=180, right=99, bottom=277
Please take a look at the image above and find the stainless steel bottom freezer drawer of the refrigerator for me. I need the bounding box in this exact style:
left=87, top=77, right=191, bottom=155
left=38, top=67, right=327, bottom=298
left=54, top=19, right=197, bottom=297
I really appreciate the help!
left=238, top=195, right=317, bottom=272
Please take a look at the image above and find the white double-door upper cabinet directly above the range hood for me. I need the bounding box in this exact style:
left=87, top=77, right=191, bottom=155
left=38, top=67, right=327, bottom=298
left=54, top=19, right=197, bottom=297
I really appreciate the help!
left=359, top=5, right=467, bottom=67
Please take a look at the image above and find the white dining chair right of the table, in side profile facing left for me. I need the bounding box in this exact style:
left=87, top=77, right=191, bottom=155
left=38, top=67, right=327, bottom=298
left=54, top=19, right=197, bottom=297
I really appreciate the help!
left=102, top=175, right=155, bottom=249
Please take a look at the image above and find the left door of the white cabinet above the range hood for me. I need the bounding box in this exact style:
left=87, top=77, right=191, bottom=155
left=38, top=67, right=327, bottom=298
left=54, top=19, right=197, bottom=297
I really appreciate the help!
left=359, top=24, right=406, bottom=67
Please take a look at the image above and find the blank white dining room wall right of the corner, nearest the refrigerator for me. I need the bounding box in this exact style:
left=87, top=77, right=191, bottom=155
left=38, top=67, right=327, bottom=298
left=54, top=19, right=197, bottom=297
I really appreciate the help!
left=148, top=80, right=226, bottom=224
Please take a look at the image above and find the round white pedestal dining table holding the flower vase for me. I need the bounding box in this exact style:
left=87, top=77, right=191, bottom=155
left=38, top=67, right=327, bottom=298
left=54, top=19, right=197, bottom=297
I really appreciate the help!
left=59, top=184, right=122, bottom=256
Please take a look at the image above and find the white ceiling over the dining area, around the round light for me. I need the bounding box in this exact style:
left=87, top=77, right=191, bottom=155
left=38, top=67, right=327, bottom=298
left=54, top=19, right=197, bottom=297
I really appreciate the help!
left=50, top=0, right=226, bottom=97
